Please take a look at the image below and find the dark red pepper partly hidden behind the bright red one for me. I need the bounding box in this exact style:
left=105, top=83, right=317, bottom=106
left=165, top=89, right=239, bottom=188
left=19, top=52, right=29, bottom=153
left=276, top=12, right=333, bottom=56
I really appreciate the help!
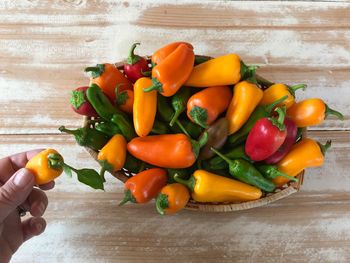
left=264, top=118, right=298, bottom=164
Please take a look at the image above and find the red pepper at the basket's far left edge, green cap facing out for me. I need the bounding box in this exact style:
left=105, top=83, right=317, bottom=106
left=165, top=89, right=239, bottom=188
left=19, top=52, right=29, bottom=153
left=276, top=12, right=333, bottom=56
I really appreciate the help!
left=70, top=86, right=98, bottom=117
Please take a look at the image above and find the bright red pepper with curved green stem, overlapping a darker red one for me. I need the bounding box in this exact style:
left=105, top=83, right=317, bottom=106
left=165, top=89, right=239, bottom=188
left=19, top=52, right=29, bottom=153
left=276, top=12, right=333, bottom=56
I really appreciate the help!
left=245, top=107, right=287, bottom=161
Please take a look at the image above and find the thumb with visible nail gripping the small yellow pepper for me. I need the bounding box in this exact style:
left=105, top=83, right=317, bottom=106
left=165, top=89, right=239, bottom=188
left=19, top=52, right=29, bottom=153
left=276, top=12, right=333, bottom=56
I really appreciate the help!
left=0, top=168, right=34, bottom=222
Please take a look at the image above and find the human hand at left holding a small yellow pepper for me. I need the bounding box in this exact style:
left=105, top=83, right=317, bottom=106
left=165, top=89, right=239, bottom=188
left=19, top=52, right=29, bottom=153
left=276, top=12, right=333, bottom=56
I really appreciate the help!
left=0, top=150, right=55, bottom=262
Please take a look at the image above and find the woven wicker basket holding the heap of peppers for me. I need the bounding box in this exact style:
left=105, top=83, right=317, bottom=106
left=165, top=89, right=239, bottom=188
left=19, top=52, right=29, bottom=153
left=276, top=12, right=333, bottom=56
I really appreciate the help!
left=83, top=57, right=306, bottom=212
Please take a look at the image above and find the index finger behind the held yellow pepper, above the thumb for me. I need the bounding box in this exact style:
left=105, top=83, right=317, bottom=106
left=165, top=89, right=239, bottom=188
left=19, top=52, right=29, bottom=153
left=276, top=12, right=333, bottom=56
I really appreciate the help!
left=0, top=149, right=44, bottom=184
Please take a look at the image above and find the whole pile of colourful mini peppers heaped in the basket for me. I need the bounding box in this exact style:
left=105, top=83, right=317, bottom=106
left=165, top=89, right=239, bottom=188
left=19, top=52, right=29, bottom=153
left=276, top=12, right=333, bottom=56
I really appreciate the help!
left=64, top=42, right=343, bottom=214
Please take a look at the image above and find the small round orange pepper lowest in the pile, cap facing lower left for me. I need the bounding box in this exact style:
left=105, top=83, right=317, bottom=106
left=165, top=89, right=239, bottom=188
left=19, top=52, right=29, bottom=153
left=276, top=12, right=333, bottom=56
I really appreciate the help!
left=156, top=183, right=190, bottom=215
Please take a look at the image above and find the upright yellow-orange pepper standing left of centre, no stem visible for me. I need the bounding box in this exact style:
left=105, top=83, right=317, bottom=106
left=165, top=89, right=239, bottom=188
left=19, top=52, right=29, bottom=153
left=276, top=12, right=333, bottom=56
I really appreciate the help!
left=133, top=77, right=157, bottom=137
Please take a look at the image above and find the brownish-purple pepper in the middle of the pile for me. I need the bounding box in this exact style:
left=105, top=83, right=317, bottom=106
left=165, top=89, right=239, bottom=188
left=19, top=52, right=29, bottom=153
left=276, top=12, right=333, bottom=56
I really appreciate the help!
left=199, top=118, right=228, bottom=160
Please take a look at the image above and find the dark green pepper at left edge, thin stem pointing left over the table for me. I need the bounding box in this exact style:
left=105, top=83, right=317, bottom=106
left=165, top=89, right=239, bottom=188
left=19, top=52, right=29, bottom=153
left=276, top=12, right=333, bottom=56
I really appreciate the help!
left=58, top=126, right=110, bottom=151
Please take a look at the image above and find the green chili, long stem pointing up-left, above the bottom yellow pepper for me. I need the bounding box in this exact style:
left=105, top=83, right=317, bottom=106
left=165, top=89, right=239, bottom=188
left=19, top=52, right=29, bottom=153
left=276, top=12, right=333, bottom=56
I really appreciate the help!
left=212, top=148, right=276, bottom=192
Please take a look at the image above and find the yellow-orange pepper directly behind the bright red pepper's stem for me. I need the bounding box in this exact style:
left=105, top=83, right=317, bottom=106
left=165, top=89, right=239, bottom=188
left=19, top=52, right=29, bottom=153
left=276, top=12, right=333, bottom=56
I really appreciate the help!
left=259, top=83, right=306, bottom=109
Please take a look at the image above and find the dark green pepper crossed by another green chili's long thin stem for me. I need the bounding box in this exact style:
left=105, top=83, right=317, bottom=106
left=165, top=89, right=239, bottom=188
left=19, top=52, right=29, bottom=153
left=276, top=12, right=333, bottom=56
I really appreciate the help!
left=206, top=144, right=250, bottom=170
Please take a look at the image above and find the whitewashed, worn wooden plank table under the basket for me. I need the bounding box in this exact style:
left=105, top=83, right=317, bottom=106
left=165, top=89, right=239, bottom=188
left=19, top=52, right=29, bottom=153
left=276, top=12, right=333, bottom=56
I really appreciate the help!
left=0, top=0, right=350, bottom=263
